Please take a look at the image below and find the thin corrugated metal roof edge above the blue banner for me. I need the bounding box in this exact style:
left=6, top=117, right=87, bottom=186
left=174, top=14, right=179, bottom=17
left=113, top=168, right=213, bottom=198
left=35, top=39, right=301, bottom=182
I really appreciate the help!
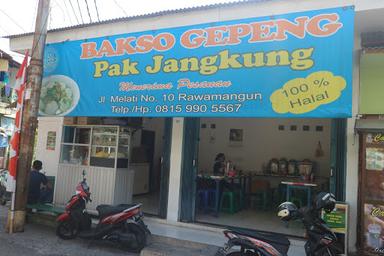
left=3, top=0, right=275, bottom=39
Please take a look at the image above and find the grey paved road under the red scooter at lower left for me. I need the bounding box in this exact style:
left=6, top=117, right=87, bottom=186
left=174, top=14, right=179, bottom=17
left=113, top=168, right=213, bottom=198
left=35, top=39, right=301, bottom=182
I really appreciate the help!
left=0, top=206, right=136, bottom=256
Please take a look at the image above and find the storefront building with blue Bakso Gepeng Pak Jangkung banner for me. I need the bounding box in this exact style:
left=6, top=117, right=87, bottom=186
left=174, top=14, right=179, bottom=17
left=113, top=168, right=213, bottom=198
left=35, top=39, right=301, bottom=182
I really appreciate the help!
left=6, top=0, right=384, bottom=255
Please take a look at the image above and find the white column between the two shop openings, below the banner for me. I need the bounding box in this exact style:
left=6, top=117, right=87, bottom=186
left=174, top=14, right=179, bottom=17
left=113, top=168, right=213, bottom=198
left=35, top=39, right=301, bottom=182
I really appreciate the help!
left=167, top=118, right=184, bottom=222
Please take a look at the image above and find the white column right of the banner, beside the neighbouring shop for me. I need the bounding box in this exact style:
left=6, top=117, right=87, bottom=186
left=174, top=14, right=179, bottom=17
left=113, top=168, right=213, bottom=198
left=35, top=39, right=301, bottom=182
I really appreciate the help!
left=345, top=32, right=363, bottom=252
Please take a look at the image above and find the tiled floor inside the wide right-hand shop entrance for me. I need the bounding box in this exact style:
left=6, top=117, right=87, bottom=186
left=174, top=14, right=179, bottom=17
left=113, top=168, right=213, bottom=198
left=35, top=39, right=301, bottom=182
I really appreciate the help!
left=196, top=210, right=304, bottom=237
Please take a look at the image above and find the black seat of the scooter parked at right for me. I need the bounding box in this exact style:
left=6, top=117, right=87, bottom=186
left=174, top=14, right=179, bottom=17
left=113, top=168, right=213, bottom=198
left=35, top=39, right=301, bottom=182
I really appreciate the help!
left=226, top=228, right=291, bottom=255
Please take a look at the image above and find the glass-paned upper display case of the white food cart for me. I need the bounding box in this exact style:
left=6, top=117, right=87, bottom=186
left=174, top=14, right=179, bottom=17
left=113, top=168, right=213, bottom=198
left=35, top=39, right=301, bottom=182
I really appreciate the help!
left=60, top=125, right=131, bottom=168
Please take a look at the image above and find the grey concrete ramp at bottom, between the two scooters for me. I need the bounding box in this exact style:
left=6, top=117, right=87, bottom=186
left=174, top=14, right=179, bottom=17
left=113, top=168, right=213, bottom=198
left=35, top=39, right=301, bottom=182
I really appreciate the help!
left=140, top=235, right=219, bottom=256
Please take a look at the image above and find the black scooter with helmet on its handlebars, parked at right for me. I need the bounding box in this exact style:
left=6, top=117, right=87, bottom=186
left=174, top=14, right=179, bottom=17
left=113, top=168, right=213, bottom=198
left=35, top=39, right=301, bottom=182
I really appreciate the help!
left=216, top=192, right=343, bottom=256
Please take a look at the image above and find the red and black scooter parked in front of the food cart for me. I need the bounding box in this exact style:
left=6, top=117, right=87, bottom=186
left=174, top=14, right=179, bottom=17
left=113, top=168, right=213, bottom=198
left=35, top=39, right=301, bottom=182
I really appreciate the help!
left=56, top=171, right=150, bottom=252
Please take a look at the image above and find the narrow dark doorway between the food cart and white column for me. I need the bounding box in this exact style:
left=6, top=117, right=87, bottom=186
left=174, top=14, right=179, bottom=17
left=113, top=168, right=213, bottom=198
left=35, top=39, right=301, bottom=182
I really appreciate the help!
left=130, top=118, right=172, bottom=218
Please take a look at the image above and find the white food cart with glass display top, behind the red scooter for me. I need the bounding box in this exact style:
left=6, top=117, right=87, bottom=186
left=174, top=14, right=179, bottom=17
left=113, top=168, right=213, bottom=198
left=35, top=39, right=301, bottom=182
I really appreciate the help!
left=55, top=125, right=135, bottom=210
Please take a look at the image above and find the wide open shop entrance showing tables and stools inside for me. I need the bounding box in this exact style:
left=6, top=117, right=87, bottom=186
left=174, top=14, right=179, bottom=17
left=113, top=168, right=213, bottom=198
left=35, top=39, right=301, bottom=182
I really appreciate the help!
left=180, top=118, right=346, bottom=237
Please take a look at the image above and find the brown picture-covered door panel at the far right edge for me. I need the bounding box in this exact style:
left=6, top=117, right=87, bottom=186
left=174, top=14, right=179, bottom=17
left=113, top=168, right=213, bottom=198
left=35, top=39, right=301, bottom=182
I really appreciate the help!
left=360, top=132, right=384, bottom=255
